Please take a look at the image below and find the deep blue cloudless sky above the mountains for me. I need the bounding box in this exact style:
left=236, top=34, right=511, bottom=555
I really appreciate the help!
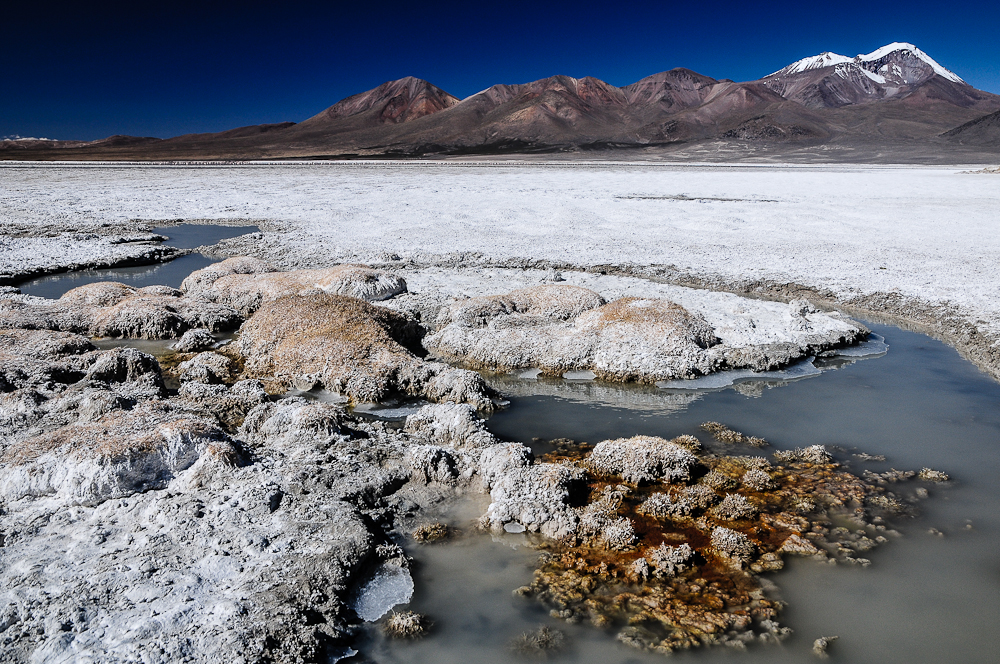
left=0, top=0, right=1000, bottom=140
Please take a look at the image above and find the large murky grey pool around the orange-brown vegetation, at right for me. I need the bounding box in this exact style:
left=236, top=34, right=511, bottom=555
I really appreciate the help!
left=370, top=325, right=1000, bottom=664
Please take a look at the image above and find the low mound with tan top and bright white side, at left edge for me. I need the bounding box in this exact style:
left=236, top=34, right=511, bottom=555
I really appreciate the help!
left=0, top=402, right=230, bottom=505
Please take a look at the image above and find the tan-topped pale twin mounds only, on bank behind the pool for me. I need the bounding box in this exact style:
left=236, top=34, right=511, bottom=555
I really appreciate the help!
left=424, top=285, right=718, bottom=382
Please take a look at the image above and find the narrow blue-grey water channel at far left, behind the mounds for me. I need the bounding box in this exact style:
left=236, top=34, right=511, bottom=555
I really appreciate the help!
left=18, top=224, right=260, bottom=299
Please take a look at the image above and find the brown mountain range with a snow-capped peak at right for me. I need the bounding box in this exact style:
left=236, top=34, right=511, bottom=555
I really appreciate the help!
left=0, top=43, right=1000, bottom=159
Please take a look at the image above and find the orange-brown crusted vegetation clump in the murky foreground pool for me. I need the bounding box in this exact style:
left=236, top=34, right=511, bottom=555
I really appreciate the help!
left=518, top=428, right=934, bottom=653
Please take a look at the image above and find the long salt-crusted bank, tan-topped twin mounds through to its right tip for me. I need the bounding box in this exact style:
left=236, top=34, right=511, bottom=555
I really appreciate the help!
left=424, top=285, right=868, bottom=383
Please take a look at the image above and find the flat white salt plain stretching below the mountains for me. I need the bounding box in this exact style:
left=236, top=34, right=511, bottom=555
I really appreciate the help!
left=0, top=162, right=1000, bottom=365
